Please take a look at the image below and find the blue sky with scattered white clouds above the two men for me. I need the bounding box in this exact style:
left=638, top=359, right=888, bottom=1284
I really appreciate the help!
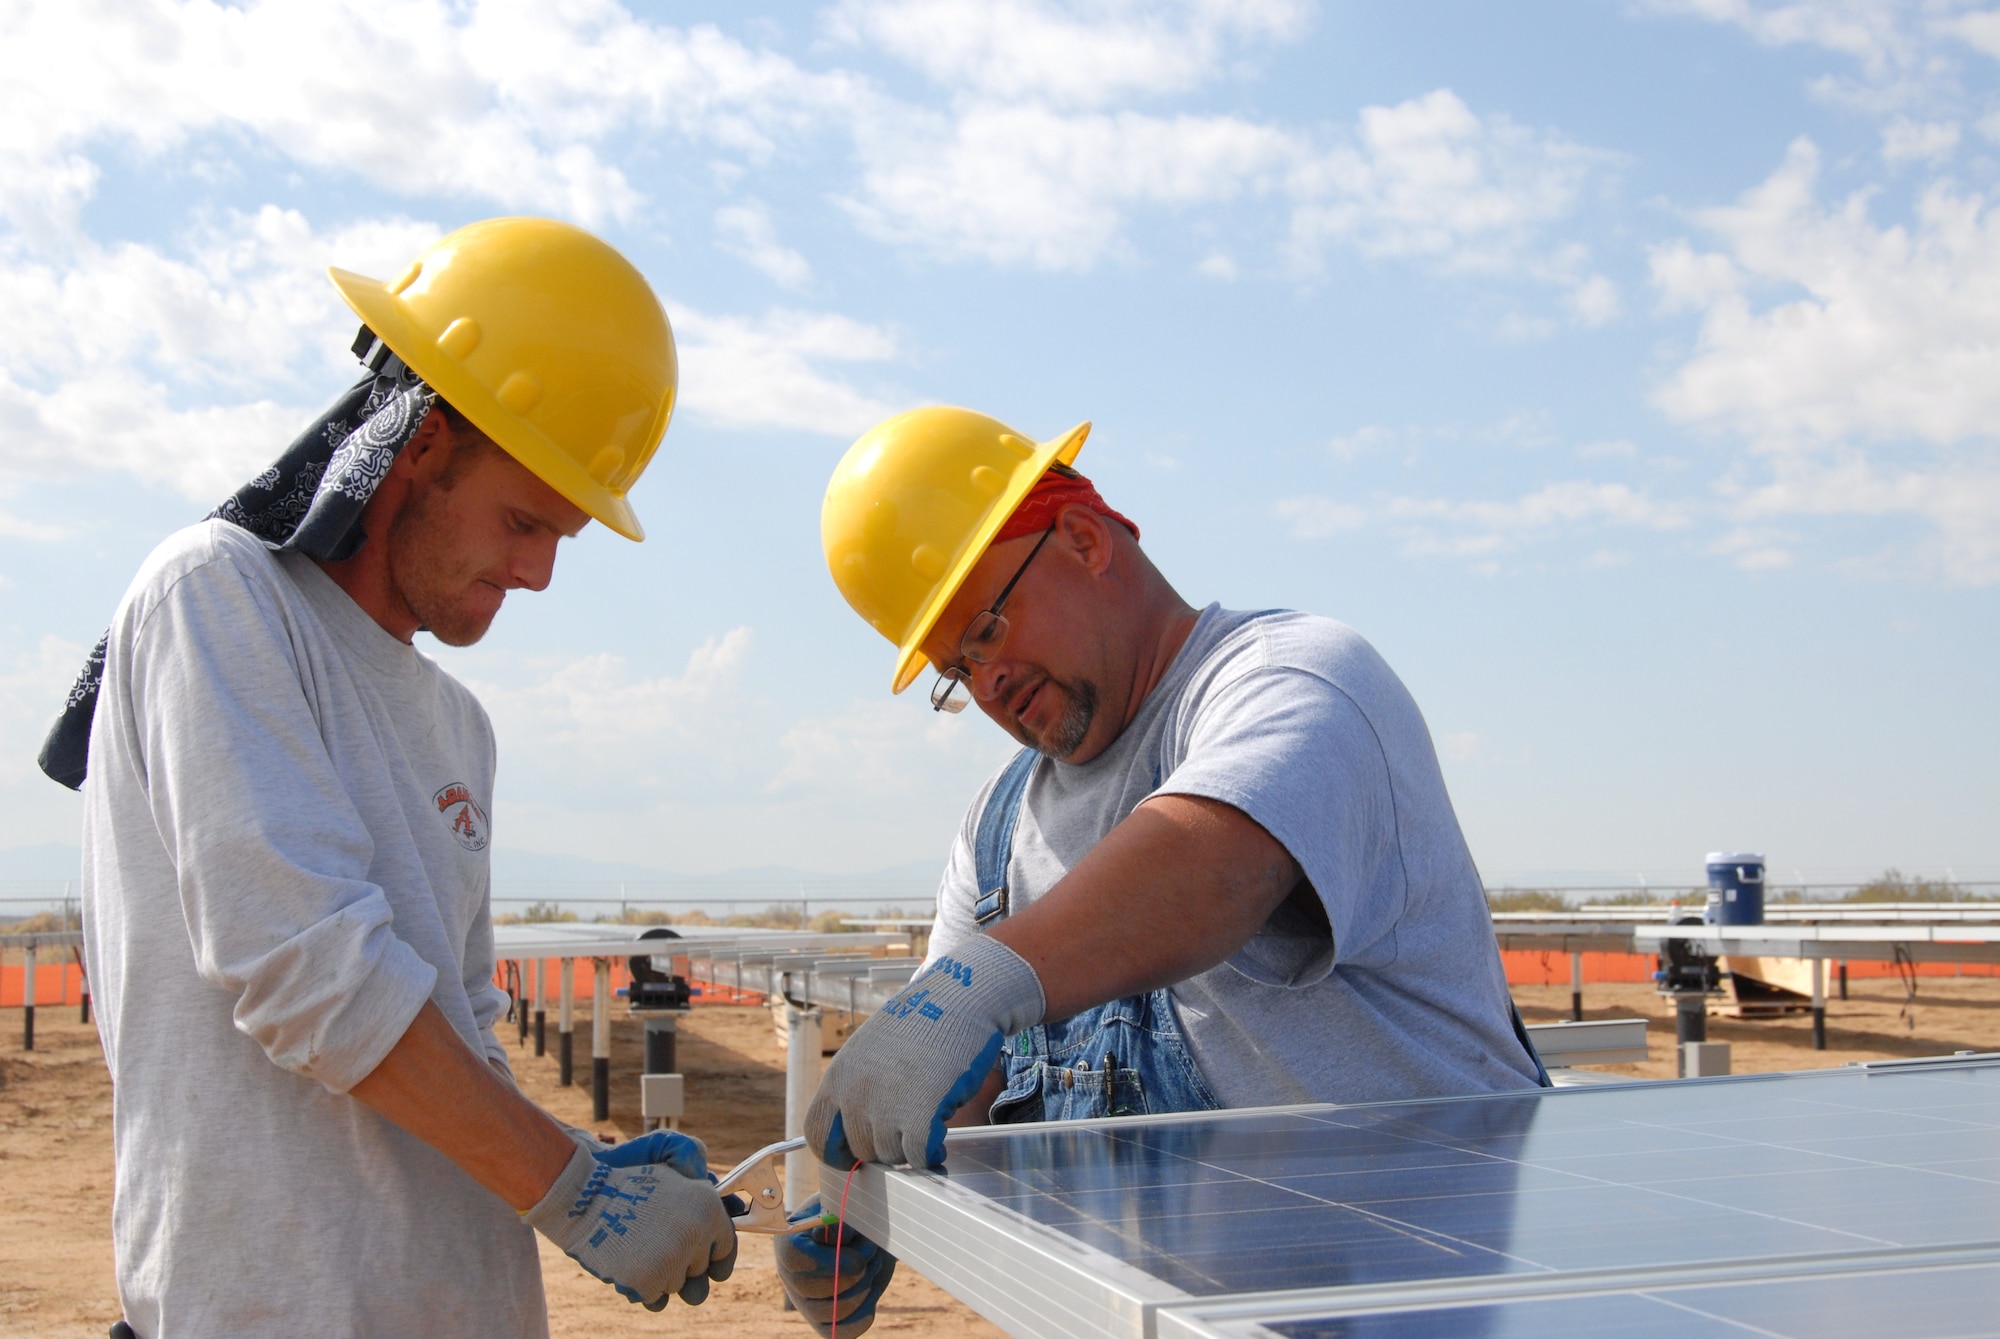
left=0, top=0, right=2000, bottom=883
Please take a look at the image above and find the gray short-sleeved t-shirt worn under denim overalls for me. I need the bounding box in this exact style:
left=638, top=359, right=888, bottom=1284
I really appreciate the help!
left=930, top=606, right=1536, bottom=1107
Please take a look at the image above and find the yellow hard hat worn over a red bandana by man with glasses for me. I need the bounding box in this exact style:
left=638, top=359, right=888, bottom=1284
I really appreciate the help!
left=820, top=406, right=1090, bottom=693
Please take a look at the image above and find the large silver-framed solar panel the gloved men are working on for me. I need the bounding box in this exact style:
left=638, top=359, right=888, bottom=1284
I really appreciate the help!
left=850, top=1061, right=2000, bottom=1337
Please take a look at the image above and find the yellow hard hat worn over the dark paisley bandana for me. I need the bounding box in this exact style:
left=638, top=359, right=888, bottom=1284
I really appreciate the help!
left=326, top=218, right=680, bottom=540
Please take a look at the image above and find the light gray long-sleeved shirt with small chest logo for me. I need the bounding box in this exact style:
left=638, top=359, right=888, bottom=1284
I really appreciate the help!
left=84, top=522, right=548, bottom=1339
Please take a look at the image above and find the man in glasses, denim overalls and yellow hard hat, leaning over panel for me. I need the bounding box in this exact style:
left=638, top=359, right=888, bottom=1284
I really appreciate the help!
left=778, top=408, right=1546, bottom=1335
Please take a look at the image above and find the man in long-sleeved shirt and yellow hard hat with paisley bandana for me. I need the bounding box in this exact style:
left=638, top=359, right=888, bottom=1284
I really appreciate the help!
left=42, top=218, right=736, bottom=1339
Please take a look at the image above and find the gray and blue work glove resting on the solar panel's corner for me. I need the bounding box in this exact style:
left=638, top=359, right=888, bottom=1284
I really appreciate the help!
left=806, top=935, right=1044, bottom=1171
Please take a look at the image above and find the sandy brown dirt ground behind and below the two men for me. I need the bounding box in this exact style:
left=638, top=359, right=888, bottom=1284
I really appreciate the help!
left=0, top=977, right=2000, bottom=1339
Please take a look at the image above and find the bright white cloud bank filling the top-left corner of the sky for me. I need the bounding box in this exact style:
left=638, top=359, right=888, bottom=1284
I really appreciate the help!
left=0, top=0, right=852, bottom=228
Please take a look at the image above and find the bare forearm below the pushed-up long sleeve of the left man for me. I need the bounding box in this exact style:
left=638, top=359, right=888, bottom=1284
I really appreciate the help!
left=350, top=1003, right=576, bottom=1209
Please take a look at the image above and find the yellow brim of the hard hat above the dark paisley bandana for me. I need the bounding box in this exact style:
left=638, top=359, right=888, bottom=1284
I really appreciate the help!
left=326, top=266, right=646, bottom=542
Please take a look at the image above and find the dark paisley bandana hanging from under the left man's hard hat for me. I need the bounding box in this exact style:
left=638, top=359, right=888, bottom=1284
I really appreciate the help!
left=36, top=326, right=438, bottom=789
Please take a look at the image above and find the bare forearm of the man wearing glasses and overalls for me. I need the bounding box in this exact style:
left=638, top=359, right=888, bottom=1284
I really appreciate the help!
left=994, top=795, right=1302, bottom=1019
